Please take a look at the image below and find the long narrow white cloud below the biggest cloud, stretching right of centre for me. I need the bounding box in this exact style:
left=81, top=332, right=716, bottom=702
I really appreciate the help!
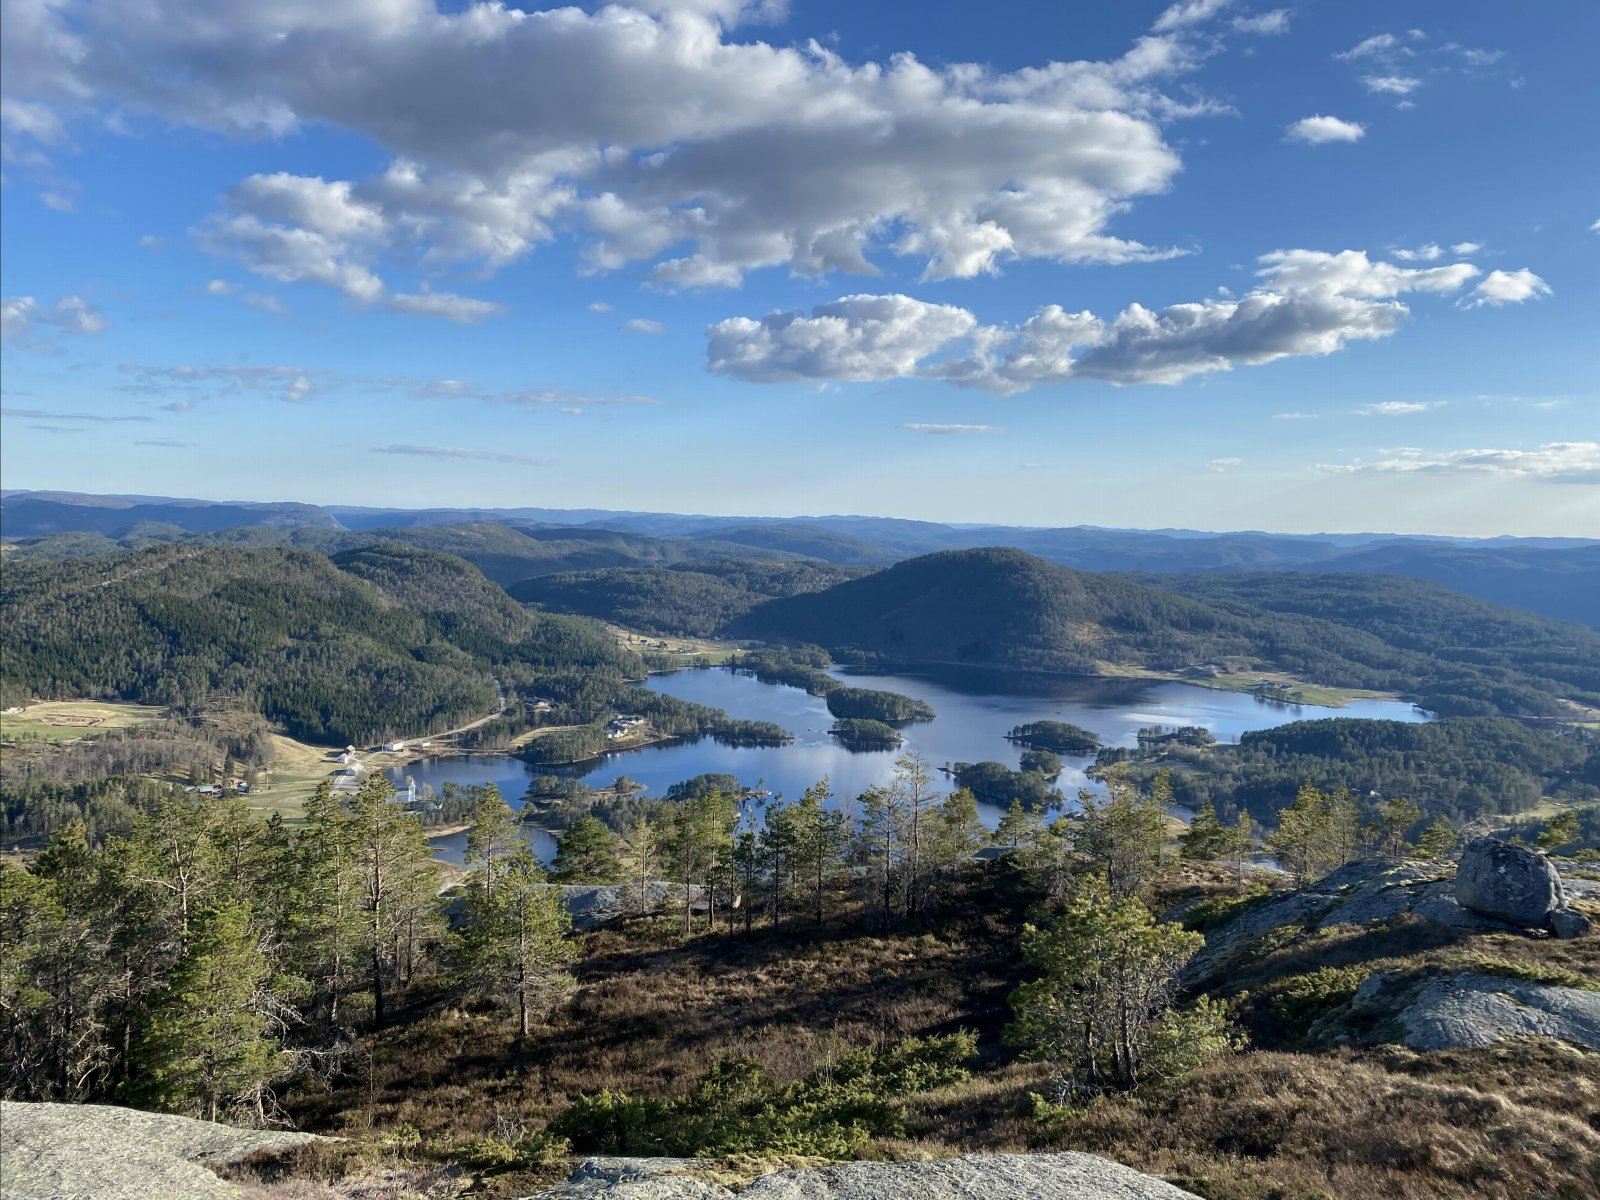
left=707, top=250, right=1536, bottom=395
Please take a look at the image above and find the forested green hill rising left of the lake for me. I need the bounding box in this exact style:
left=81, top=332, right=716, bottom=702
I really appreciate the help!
left=0, top=546, right=640, bottom=742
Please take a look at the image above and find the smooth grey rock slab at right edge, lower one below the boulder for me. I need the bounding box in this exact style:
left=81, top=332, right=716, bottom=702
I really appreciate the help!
left=1352, top=971, right=1600, bottom=1050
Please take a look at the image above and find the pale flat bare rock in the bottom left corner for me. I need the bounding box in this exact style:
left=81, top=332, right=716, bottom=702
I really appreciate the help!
left=0, top=1101, right=317, bottom=1200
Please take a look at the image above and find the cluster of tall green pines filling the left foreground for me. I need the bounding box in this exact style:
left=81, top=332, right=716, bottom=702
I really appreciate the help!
left=0, top=776, right=573, bottom=1122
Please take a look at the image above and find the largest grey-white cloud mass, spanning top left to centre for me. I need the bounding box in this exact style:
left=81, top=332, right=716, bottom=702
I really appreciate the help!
left=5, top=0, right=1224, bottom=297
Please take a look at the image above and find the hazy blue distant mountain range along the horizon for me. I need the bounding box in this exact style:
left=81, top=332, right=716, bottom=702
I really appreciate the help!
left=9, top=491, right=1600, bottom=627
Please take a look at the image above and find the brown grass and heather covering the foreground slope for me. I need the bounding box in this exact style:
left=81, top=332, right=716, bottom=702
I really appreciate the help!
left=286, top=870, right=1600, bottom=1200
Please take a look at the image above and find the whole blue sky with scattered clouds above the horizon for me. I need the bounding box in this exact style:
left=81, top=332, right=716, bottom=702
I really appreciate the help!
left=0, top=0, right=1600, bottom=536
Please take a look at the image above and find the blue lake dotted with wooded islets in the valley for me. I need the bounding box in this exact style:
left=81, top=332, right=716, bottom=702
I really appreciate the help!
left=389, top=667, right=1427, bottom=861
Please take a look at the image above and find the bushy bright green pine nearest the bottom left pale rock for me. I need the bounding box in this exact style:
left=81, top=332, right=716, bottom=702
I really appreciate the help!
left=133, top=901, right=285, bottom=1120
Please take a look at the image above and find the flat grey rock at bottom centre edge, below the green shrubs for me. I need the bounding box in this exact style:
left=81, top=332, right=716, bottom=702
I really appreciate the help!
left=538, top=1154, right=1195, bottom=1200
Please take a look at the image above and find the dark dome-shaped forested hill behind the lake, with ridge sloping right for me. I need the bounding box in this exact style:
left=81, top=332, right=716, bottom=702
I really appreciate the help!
left=731, top=549, right=1600, bottom=715
